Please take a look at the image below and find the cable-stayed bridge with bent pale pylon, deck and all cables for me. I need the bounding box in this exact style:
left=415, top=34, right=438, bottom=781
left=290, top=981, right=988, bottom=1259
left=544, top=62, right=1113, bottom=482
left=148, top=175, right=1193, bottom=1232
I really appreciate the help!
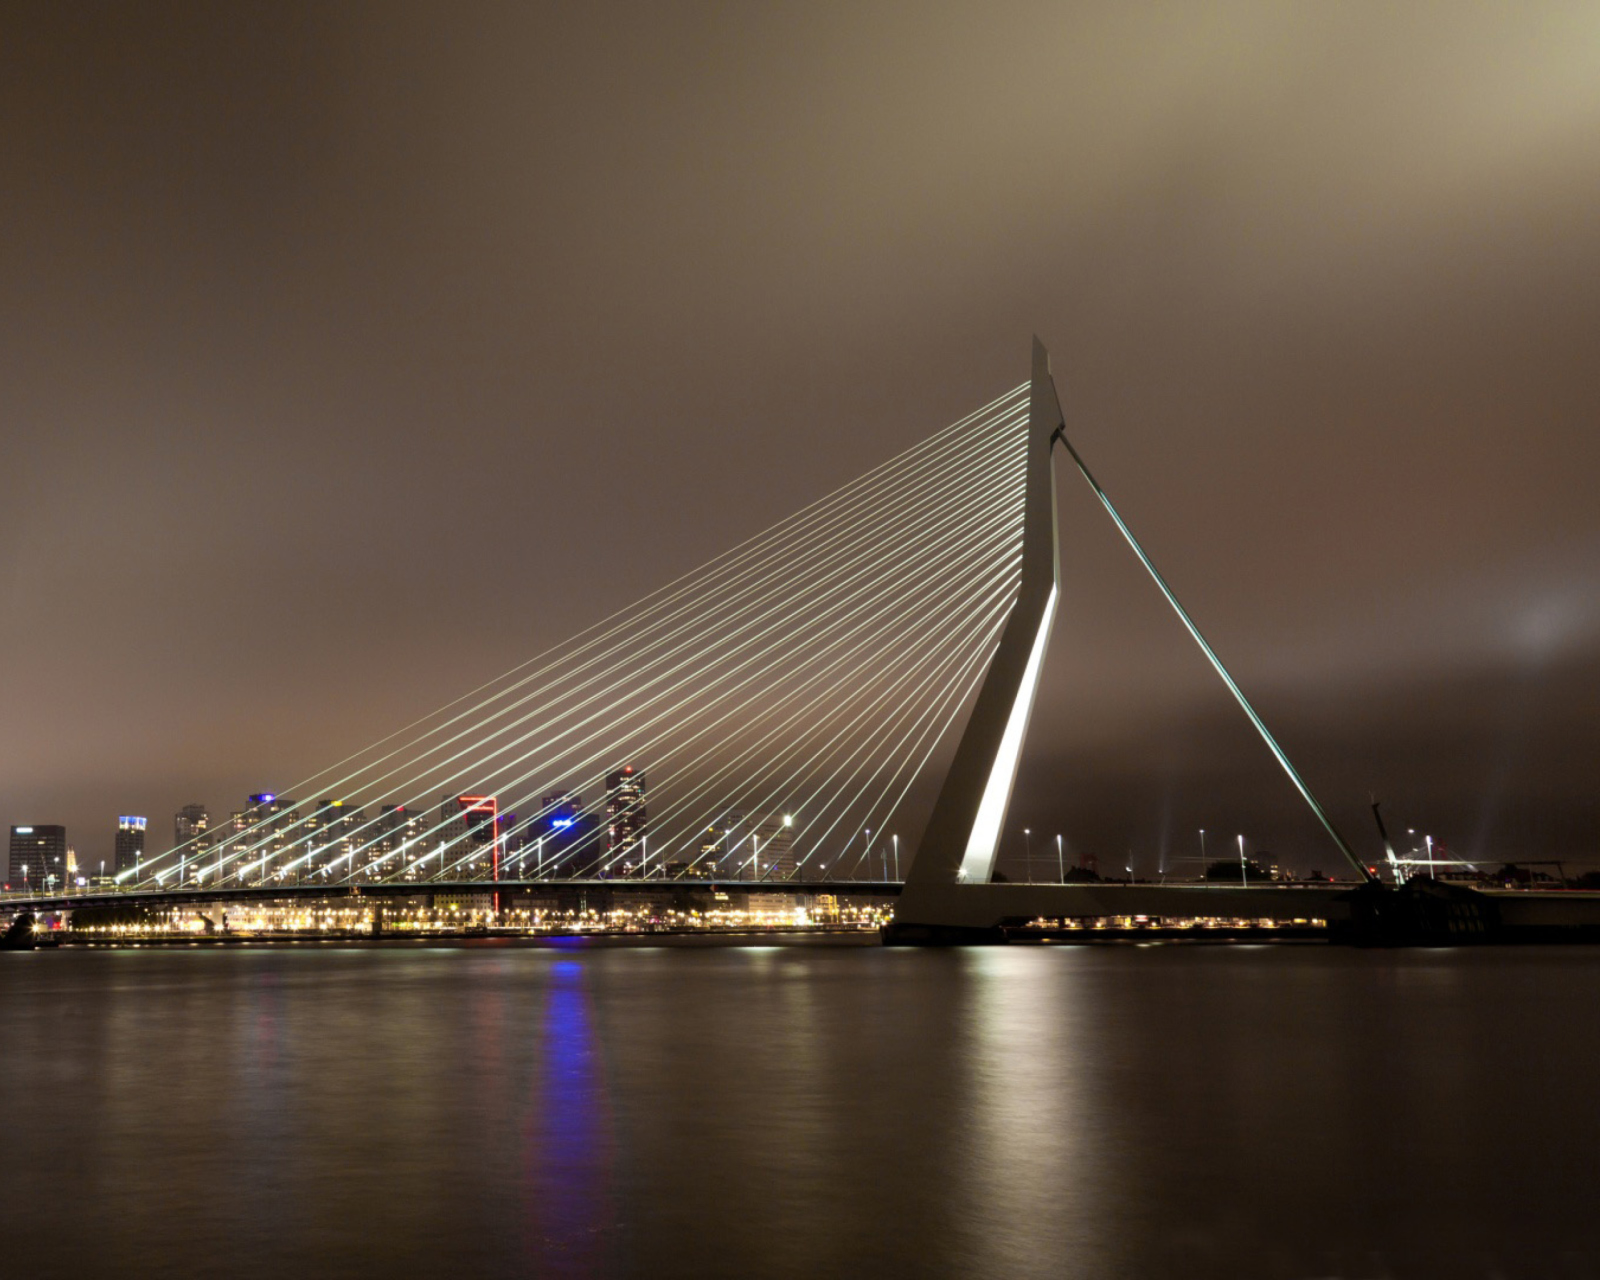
left=5, top=339, right=1600, bottom=944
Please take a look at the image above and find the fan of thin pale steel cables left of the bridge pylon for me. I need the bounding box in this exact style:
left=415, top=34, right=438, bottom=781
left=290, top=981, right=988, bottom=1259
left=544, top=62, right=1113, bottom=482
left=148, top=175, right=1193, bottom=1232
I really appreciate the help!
left=123, top=386, right=1027, bottom=888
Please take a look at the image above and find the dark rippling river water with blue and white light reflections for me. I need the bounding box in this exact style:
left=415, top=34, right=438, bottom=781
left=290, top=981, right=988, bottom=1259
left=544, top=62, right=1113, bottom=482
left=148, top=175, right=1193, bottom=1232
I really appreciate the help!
left=0, top=942, right=1600, bottom=1280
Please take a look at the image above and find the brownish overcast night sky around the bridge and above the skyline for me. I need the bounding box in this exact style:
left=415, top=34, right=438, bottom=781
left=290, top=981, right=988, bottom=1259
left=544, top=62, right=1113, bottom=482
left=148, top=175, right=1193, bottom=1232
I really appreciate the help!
left=0, top=0, right=1600, bottom=874
